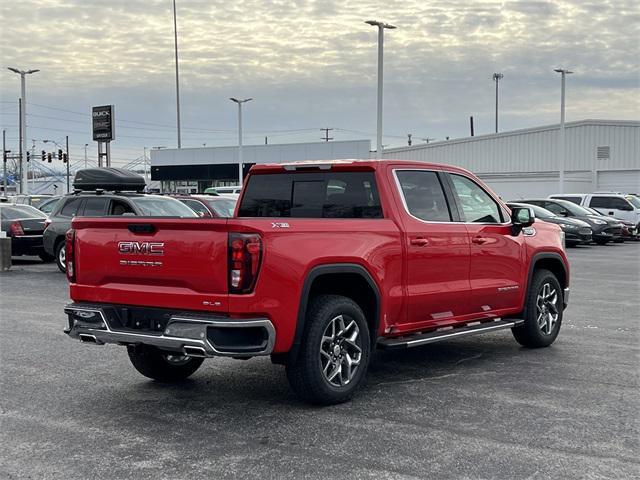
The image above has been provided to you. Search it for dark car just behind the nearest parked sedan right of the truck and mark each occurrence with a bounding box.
[520,198,622,245]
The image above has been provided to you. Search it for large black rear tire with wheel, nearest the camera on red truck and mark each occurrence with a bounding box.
[286,295,371,405]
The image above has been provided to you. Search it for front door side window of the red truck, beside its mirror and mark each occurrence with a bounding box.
[450,174,504,223]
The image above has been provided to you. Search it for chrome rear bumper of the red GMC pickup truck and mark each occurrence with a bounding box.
[64,303,276,357]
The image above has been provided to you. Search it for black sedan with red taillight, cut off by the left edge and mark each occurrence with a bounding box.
[0,203,53,262]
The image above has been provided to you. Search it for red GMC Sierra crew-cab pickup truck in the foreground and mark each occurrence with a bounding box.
[65,160,569,404]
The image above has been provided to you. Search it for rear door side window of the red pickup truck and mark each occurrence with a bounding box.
[396,170,451,222]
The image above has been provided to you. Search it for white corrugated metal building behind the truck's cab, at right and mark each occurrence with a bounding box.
[383,120,640,199]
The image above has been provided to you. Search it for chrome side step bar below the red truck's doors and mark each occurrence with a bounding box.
[378,318,524,350]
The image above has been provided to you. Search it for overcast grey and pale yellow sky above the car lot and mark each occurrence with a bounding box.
[0,0,640,166]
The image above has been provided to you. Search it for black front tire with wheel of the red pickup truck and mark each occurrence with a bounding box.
[511,269,563,348]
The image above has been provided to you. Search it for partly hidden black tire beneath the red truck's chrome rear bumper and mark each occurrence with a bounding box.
[127,345,204,383]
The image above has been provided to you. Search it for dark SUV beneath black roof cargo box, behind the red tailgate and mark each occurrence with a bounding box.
[44,191,196,272]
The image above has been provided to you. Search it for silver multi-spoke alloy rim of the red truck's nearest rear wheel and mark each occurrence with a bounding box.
[320,315,362,387]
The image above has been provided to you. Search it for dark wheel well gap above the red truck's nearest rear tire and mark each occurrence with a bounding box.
[305,273,379,343]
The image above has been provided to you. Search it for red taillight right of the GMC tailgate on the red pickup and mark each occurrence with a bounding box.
[229,233,262,293]
